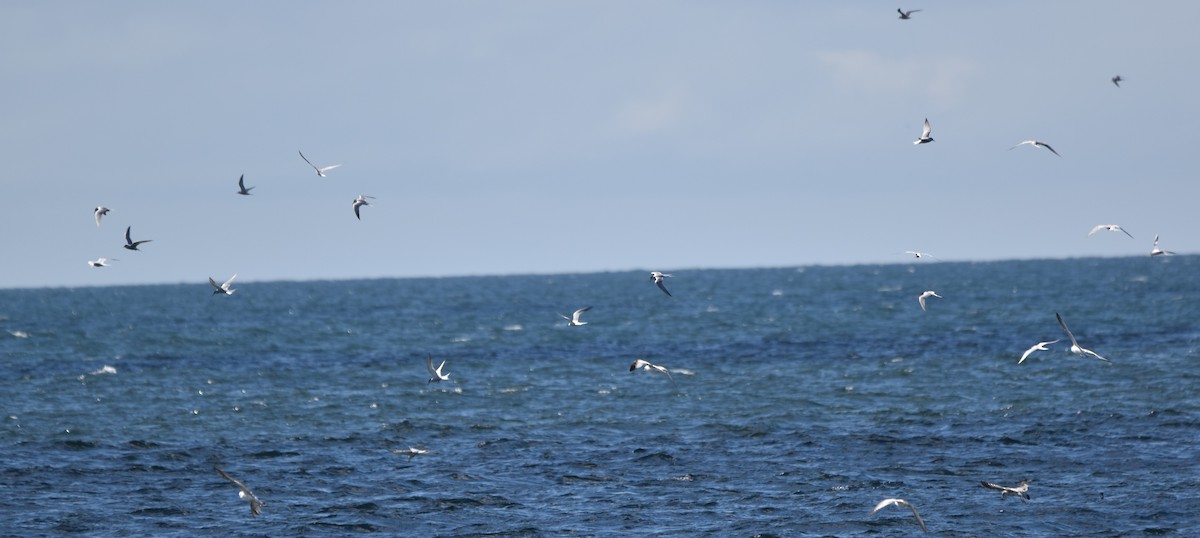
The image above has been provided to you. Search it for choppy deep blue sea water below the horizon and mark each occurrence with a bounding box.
[0,256,1200,537]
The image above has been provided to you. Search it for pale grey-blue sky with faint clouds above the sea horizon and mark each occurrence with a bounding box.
[0,0,1200,287]
